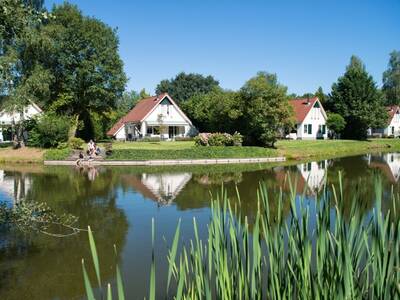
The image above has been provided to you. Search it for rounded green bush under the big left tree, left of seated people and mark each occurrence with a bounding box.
[28,113,71,148]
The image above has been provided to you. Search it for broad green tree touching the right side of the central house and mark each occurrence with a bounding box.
[182,87,243,133]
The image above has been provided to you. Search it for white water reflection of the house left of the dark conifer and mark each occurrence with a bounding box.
[297,160,329,192]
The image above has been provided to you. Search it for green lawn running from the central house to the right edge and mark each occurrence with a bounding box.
[104,139,400,160]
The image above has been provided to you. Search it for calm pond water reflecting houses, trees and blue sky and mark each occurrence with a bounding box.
[0,153,400,300]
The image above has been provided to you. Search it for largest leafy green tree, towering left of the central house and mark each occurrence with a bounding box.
[26,3,127,139]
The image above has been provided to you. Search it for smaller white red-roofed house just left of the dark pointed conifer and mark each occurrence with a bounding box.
[289,97,328,140]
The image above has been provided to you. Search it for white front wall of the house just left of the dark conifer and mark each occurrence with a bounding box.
[297,107,328,140]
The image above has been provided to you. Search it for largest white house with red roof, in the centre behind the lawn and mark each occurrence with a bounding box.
[107,93,196,141]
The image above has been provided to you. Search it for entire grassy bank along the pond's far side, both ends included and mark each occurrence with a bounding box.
[0,139,400,163]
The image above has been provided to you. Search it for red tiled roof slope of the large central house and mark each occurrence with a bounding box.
[107,93,167,136]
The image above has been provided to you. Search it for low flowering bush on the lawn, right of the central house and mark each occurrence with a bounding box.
[194,132,243,146]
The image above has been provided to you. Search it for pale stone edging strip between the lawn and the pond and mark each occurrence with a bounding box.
[44,156,286,166]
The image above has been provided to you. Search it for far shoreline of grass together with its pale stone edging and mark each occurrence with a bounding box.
[0,139,400,166]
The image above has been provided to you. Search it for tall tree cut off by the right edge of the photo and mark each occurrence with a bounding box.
[382,51,400,105]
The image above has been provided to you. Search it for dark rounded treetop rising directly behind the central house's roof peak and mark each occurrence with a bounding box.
[156,72,219,103]
